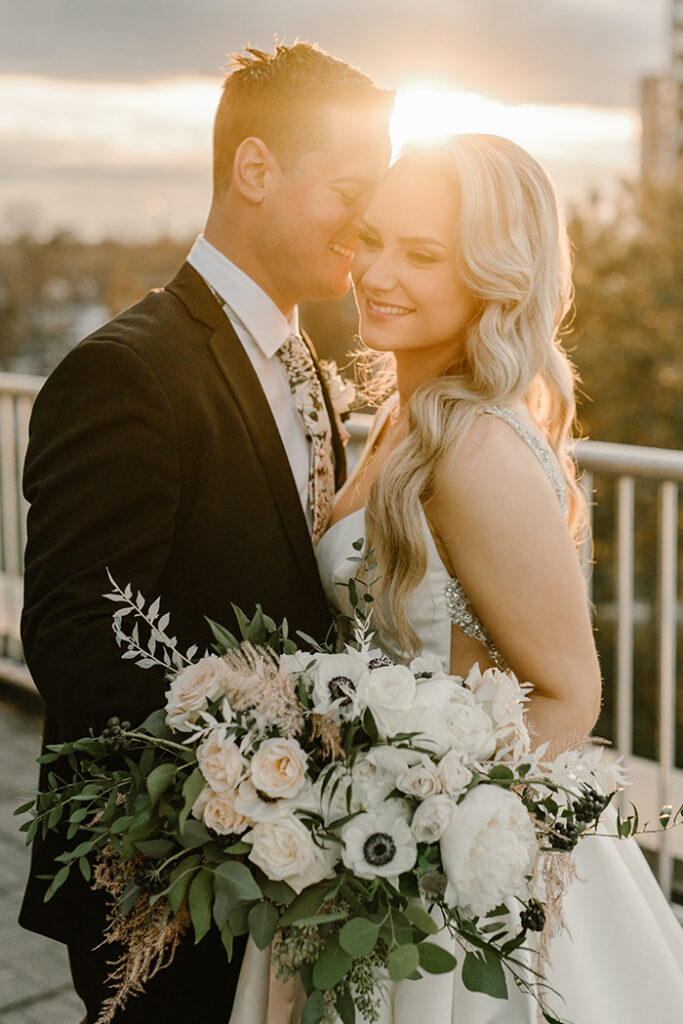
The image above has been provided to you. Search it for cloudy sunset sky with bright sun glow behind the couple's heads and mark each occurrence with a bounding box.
[0,0,670,240]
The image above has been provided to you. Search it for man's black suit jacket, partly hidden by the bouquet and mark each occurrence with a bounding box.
[19,263,345,942]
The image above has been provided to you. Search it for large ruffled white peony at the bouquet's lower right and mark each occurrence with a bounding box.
[440,785,538,916]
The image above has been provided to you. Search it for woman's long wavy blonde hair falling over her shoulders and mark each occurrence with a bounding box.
[367,135,585,652]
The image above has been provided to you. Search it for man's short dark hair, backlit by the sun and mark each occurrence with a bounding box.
[213,43,393,191]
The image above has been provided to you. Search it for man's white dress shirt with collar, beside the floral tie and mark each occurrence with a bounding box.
[187,234,312,529]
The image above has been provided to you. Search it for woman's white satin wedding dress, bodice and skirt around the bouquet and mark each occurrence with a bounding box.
[230,407,683,1024]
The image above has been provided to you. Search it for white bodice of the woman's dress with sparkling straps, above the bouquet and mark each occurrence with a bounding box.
[317,406,567,668]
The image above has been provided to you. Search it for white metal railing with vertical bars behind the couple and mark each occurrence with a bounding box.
[0,385,683,897]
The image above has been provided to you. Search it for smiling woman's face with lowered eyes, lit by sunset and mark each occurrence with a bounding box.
[351,160,475,372]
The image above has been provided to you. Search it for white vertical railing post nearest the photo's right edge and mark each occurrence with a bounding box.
[657,480,678,899]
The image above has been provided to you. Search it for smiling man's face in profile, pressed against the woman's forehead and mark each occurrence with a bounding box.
[264,105,390,311]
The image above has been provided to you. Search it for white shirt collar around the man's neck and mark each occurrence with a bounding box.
[187,234,299,359]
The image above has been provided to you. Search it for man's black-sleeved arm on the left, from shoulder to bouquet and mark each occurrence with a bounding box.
[22,340,179,735]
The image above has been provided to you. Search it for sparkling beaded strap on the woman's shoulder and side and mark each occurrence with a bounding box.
[445,406,568,669]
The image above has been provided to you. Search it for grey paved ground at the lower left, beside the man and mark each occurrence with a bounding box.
[0,683,85,1024]
